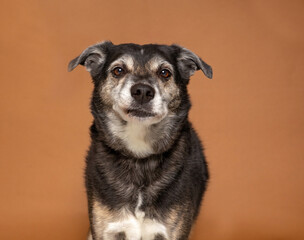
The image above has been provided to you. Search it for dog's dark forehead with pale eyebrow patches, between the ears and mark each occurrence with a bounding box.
[110,44,173,70]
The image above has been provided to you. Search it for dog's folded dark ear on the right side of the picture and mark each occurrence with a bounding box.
[173,45,212,80]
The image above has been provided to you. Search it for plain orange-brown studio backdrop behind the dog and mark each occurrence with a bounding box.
[0,0,304,240]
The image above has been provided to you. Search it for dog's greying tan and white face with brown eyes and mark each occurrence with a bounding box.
[99,49,180,125]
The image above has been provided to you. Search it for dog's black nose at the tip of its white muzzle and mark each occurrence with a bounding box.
[131,83,155,104]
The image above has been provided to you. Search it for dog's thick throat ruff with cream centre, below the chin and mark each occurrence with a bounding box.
[93,108,188,158]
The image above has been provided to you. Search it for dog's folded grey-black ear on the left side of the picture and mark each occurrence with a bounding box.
[68,41,113,75]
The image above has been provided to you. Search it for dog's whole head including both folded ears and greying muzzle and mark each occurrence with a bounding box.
[68,41,212,156]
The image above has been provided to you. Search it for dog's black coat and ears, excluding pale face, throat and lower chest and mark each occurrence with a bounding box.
[69,42,212,240]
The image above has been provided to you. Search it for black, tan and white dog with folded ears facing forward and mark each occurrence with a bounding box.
[68,41,212,240]
